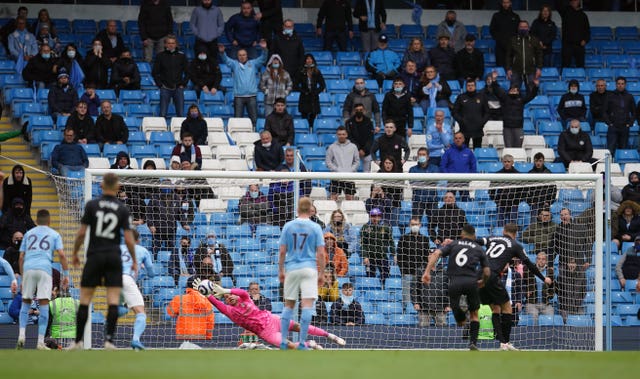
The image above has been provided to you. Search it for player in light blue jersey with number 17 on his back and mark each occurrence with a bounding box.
[278,197,325,350]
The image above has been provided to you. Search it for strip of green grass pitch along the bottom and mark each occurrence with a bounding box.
[0,350,639,379]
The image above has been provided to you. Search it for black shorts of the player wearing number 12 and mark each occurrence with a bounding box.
[80,251,122,287]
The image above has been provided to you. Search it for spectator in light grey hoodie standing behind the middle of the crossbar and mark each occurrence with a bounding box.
[325,126,360,200]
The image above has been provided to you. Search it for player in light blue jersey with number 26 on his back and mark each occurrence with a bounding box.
[16,209,69,350]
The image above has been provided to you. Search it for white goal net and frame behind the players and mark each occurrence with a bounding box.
[59,170,610,350]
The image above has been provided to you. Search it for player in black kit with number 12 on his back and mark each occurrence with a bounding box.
[69,173,138,350]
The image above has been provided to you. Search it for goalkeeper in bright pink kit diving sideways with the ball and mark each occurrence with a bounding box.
[193,279,346,350]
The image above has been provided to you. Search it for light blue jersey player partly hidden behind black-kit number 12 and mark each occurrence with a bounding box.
[120,229,155,350]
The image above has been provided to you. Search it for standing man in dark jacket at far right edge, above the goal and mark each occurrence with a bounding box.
[604,76,636,156]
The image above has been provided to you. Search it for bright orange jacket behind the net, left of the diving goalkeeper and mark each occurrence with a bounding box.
[167,288,215,340]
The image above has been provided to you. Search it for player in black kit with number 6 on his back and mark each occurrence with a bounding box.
[422,224,490,350]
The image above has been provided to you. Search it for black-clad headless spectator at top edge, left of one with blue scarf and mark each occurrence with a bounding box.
[316,0,353,51]
